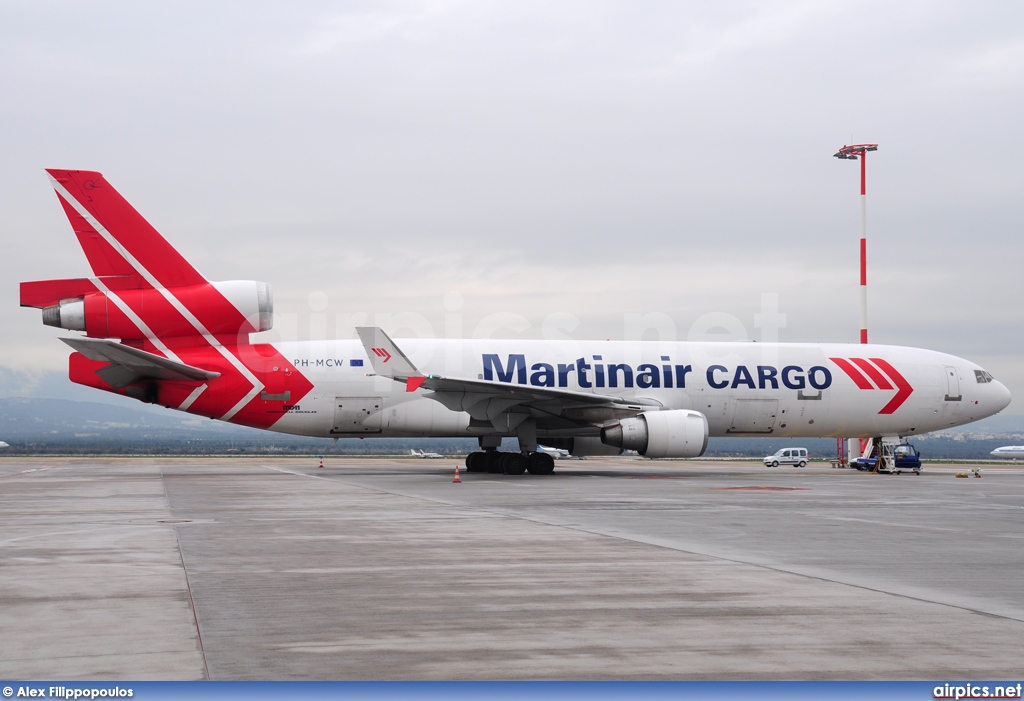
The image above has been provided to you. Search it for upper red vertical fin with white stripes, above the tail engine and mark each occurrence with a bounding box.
[46,168,207,288]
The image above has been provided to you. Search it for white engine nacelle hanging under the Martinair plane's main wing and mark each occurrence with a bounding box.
[601,409,708,457]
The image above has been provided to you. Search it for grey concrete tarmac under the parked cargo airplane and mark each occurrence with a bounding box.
[0,457,1024,681]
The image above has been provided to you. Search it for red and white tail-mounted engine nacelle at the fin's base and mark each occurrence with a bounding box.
[43,280,273,339]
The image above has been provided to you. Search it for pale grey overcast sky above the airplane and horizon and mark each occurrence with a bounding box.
[0,0,1024,418]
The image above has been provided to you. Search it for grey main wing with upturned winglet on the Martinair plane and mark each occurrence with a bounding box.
[355,326,662,428]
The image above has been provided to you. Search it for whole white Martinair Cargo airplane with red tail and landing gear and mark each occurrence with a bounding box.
[20,170,1010,474]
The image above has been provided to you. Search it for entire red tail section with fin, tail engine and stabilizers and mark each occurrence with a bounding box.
[22,170,313,428]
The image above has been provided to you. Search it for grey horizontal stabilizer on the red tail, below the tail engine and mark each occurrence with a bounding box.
[60,339,220,389]
